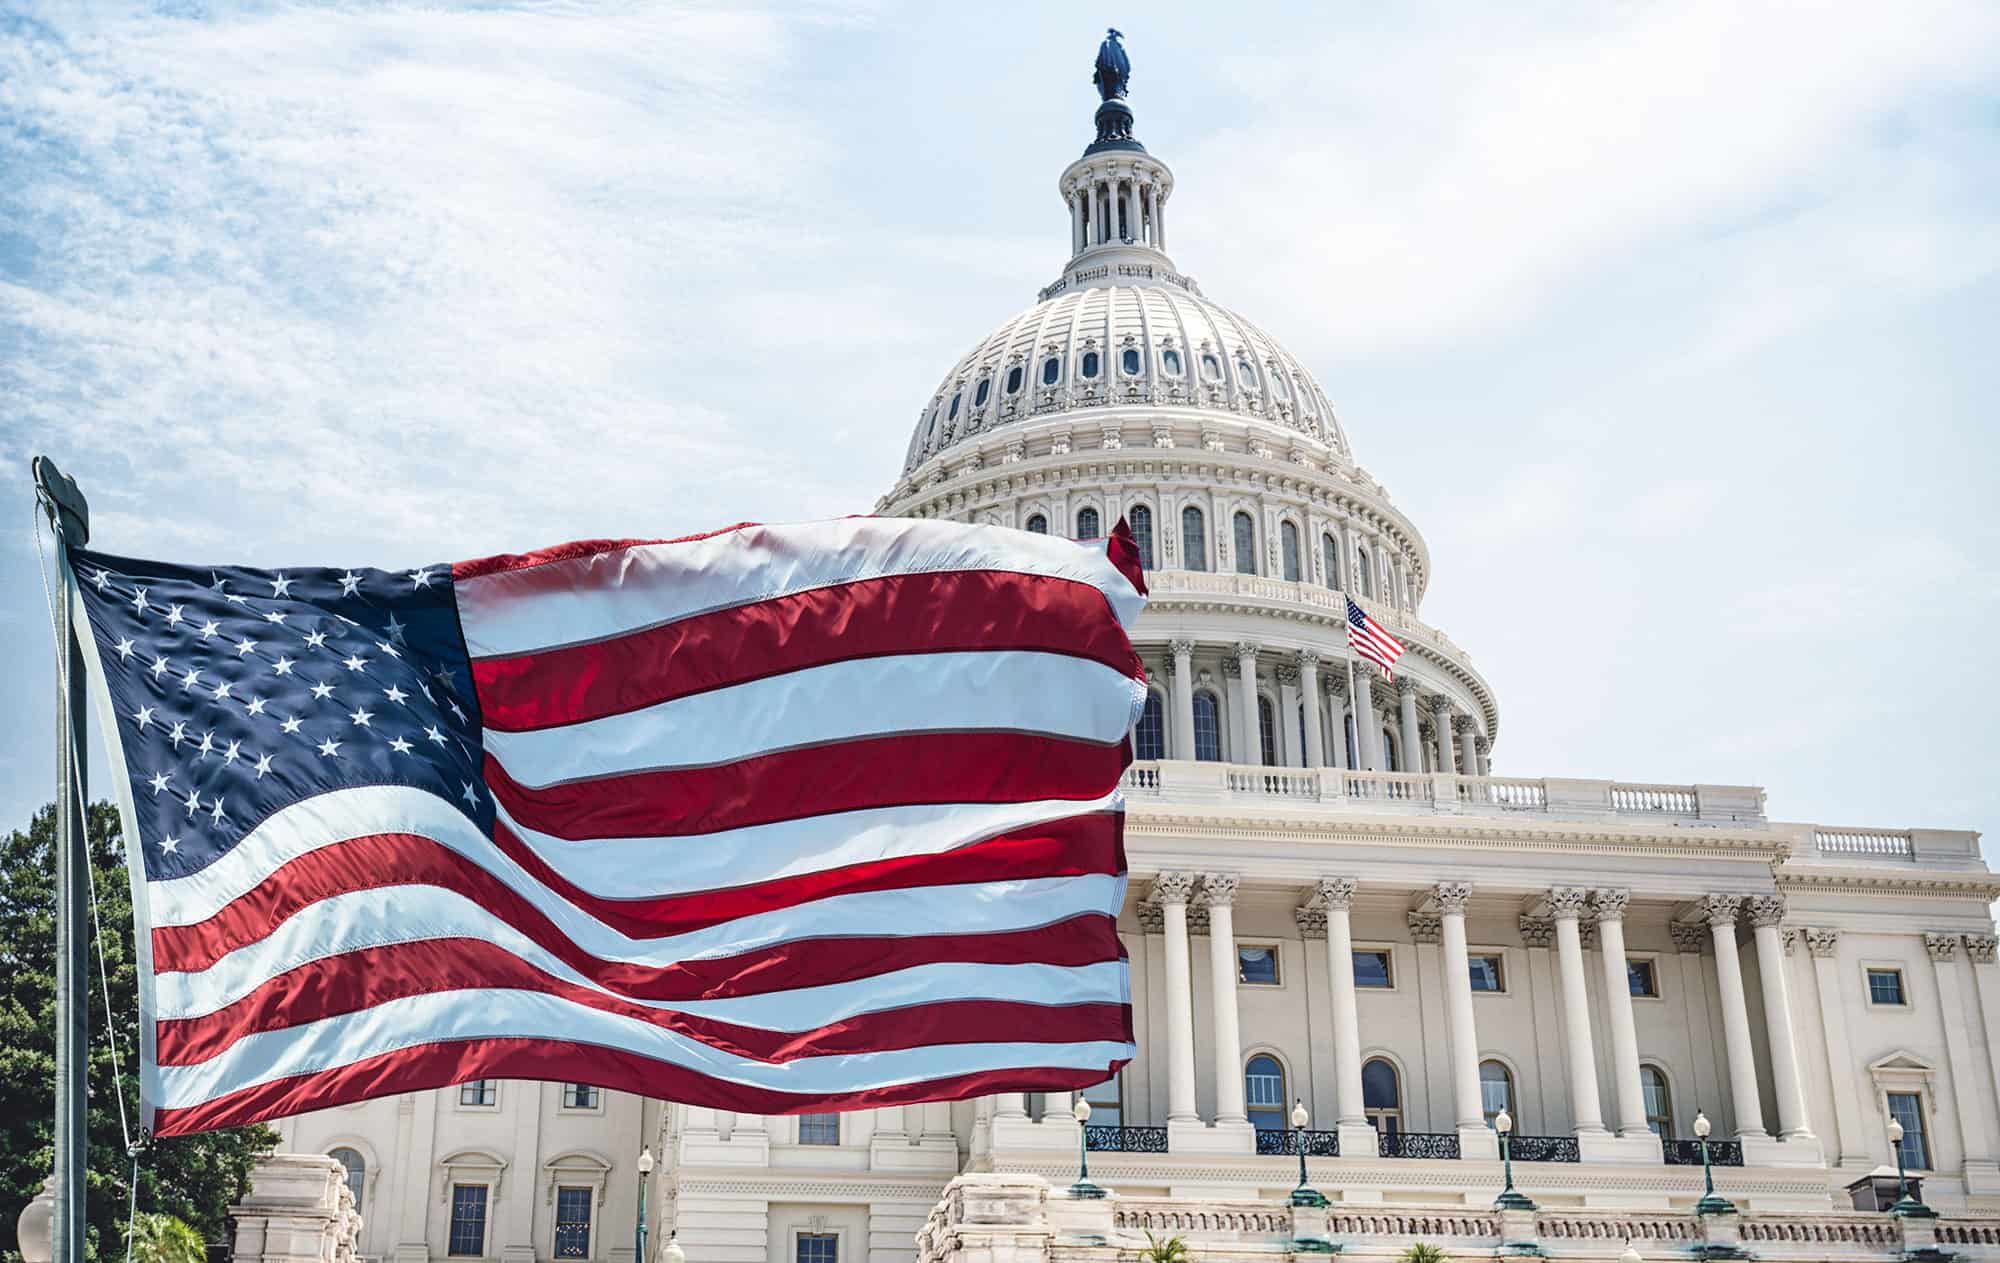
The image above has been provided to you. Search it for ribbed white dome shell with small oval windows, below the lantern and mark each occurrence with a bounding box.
[904,277,1352,472]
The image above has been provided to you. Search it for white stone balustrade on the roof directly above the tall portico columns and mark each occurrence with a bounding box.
[1124,759,1764,823]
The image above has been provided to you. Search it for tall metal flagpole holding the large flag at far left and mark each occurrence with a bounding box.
[34,456,90,1263]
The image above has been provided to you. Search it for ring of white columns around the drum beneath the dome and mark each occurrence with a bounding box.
[1162,639,1492,775]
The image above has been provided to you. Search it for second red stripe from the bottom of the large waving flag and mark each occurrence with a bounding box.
[158,939,1132,1065]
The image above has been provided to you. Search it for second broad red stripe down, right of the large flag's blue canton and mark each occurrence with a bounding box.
[486,731,1132,837]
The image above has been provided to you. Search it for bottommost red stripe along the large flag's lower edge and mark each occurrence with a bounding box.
[154,1039,1124,1135]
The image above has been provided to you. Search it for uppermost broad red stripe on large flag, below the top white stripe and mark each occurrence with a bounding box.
[472,571,1146,731]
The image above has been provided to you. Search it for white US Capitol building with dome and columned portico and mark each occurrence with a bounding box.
[258,38,2000,1263]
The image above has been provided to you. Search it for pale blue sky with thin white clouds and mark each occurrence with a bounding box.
[0,0,2000,863]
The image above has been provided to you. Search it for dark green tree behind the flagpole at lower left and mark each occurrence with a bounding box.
[0,803,278,1263]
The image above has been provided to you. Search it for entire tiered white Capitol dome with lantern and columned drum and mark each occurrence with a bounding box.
[878,40,1500,771]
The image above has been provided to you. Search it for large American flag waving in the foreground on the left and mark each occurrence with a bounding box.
[70,518,1144,1135]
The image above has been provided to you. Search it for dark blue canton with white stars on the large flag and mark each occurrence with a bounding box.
[70,550,492,881]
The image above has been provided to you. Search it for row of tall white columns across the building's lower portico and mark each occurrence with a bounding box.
[1120,871,1816,1161]
